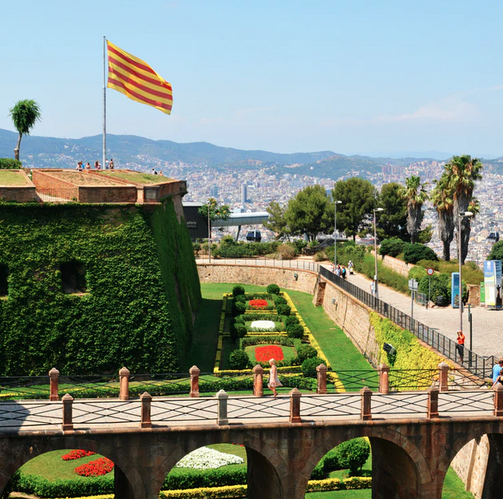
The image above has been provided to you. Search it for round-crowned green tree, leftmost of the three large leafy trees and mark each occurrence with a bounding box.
[285,185,334,241]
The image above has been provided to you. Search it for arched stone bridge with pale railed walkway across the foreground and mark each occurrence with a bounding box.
[0,380,503,499]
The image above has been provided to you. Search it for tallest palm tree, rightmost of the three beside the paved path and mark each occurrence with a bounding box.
[445,154,484,264]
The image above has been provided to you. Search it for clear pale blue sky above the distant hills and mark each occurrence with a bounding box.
[0,0,503,158]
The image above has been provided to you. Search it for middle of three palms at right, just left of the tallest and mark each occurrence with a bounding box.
[430,176,455,262]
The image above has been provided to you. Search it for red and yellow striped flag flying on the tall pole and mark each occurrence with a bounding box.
[107,40,173,114]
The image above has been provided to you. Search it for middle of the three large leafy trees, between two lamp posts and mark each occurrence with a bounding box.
[332,177,377,241]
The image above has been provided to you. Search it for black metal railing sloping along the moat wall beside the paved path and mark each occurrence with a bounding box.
[320,267,496,379]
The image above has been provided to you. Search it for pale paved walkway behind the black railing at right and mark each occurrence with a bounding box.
[330,265,503,357]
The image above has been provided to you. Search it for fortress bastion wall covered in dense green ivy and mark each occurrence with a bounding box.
[0,199,201,375]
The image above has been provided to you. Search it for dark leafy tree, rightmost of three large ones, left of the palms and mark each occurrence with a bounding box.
[376,182,408,240]
